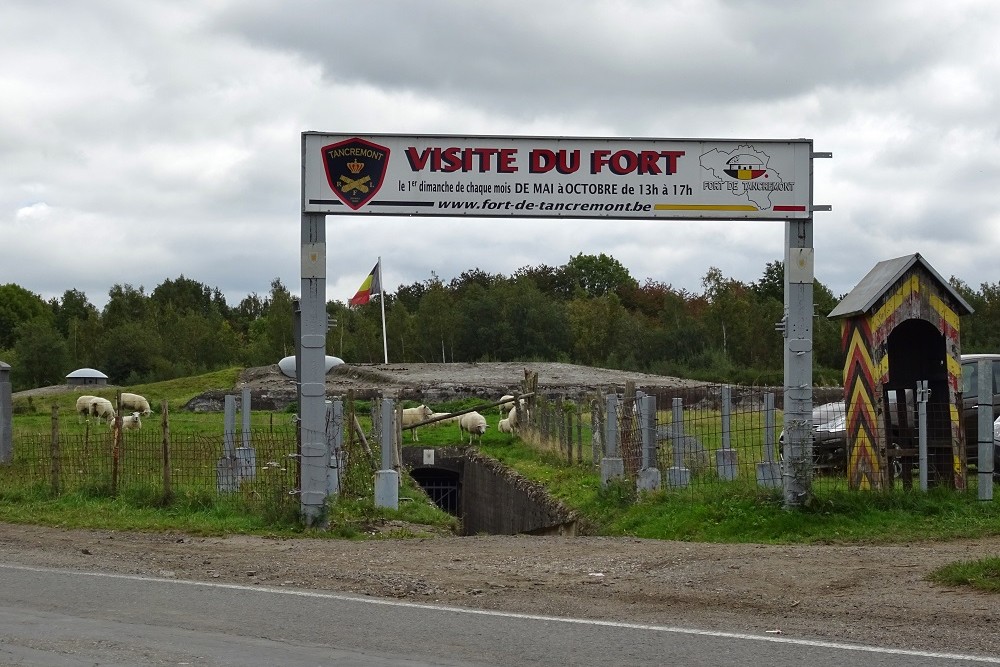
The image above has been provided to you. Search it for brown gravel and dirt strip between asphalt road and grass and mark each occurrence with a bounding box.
[0,524,1000,656]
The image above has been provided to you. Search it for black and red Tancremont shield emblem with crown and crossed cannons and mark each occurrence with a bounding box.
[322,138,389,211]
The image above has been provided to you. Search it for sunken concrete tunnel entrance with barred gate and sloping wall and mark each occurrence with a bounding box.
[402,447,577,535]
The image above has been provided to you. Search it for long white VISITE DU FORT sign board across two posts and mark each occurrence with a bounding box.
[302,132,812,220]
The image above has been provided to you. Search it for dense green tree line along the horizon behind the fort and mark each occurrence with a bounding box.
[0,253,1000,391]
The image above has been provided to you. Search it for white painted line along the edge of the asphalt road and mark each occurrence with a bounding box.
[0,563,1000,664]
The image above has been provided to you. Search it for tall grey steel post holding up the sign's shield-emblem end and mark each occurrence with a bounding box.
[296,213,330,526]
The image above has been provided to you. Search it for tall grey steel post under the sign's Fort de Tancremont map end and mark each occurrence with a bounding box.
[782,218,813,509]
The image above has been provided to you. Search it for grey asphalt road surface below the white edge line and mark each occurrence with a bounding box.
[0,565,1000,667]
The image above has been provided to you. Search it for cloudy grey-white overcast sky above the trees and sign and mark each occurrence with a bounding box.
[0,0,1000,307]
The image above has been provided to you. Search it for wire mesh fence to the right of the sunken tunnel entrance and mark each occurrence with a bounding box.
[521,384,975,493]
